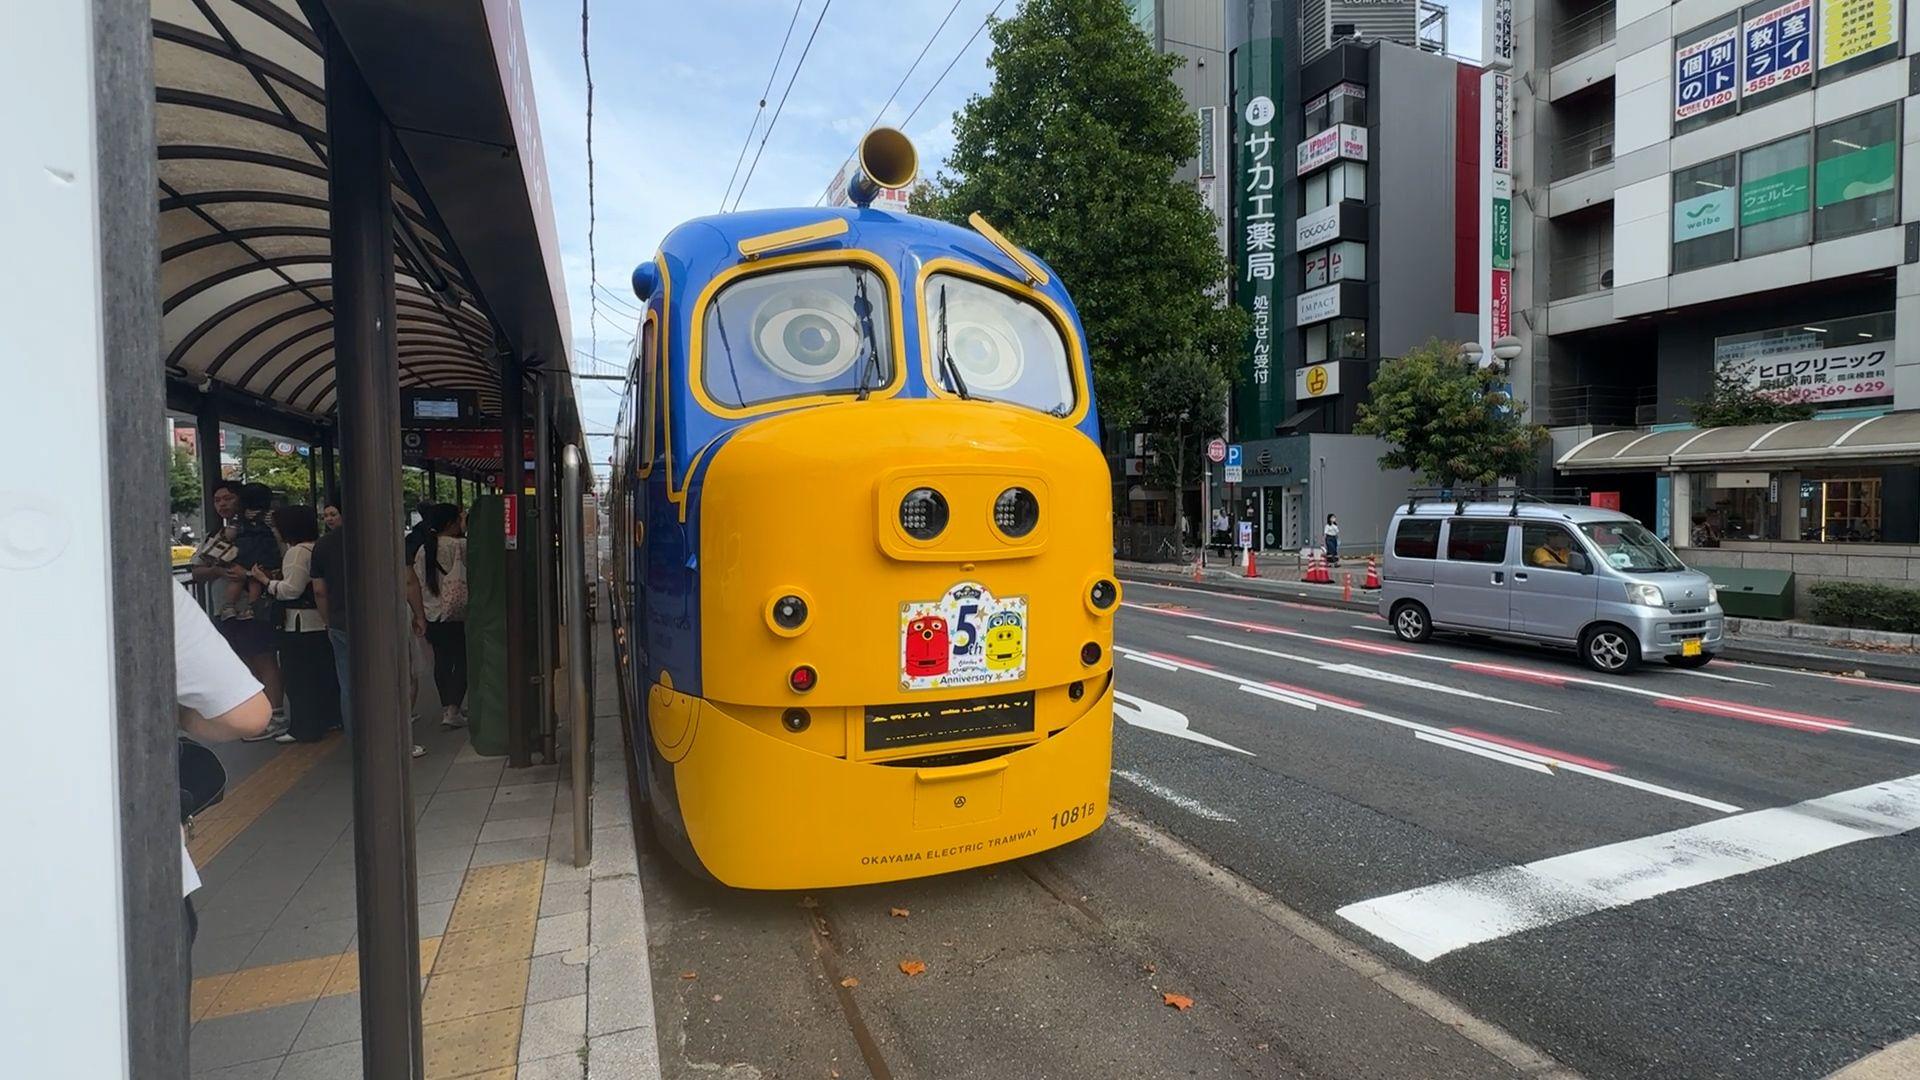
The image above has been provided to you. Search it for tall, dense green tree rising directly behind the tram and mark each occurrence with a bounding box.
[914,0,1246,430]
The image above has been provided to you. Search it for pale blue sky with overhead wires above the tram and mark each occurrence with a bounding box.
[520,0,1480,461]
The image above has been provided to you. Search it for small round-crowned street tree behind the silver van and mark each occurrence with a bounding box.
[1354,340,1548,486]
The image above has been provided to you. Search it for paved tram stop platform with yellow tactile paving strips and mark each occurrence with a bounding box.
[188,634,659,1080]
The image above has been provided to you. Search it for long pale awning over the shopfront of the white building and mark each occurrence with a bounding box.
[1553,411,1920,473]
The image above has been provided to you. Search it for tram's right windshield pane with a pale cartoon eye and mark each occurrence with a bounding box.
[922,273,1073,417]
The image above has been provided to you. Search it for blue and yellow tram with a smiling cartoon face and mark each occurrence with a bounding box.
[611,129,1119,888]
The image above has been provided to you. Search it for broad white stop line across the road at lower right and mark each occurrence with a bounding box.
[1336,776,1920,961]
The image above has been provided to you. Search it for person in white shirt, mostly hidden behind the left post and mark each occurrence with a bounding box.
[173,586,273,978]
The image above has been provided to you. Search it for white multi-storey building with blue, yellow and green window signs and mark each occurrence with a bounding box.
[1501,0,1920,592]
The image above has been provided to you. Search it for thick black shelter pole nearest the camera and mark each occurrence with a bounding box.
[326,33,422,1080]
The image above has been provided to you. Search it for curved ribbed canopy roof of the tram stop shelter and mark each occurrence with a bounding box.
[152,0,570,428]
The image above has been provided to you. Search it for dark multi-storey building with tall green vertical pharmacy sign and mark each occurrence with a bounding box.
[1221,0,1480,550]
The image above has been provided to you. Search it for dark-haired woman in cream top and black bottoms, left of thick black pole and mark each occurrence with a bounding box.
[252,505,340,742]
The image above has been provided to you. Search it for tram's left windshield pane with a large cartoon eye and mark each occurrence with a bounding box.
[701,265,893,409]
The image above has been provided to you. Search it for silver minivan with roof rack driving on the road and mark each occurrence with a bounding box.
[1380,500,1722,673]
